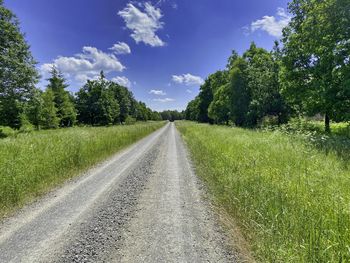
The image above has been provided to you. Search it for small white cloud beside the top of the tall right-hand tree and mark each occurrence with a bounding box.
[250,8,291,37]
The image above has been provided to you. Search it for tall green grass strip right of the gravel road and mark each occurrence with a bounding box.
[176,122,350,263]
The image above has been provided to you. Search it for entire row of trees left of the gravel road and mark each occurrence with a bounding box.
[0,0,173,129]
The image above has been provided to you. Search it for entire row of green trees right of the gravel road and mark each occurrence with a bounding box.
[185,0,350,132]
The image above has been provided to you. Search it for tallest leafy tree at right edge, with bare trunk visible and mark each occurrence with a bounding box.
[281,0,350,132]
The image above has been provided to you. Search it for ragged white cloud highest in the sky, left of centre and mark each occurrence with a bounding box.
[118,3,165,47]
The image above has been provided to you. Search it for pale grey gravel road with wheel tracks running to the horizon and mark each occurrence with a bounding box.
[0,123,237,263]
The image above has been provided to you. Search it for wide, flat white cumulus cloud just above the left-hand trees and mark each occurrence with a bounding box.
[40,46,125,82]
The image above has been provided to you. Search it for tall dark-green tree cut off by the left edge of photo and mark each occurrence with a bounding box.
[0,1,39,128]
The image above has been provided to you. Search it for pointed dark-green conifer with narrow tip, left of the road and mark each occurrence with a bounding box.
[47,67,77,127]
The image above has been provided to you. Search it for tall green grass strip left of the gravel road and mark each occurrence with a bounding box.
[0,122,164,217]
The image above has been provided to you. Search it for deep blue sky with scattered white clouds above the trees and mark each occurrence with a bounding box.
[5,0,290,110]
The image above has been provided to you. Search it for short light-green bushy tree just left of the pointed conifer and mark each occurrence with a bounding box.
[39,88,60,129]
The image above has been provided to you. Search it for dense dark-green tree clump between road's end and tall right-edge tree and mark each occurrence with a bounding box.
[185,43,289,127]
